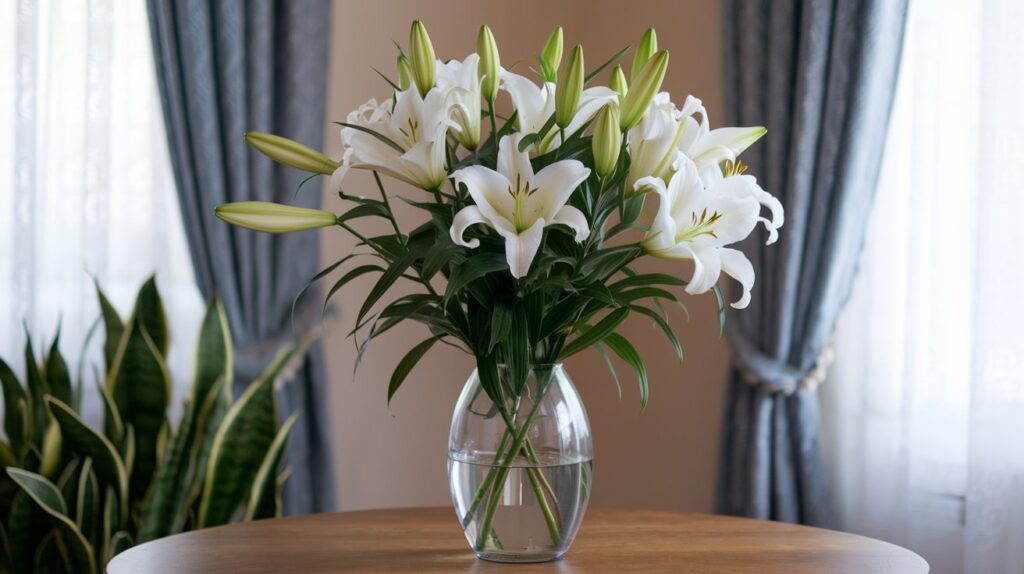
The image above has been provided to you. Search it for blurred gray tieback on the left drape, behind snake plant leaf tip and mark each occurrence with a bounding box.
[234,297,330,387]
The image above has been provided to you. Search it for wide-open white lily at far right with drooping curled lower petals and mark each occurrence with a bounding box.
[636,158,761,309]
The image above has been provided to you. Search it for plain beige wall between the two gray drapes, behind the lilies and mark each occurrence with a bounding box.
[323,0,727,512]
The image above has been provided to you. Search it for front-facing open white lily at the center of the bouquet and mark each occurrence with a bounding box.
[452,134,590,278]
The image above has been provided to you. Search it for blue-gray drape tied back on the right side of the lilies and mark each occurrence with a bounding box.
[718,0,906,526]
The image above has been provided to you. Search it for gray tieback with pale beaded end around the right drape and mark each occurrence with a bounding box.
[729,335,836,395]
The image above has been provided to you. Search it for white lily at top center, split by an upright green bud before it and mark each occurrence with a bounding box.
[502,69,618,157]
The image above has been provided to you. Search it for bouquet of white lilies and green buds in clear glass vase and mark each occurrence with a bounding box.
[217,21,782,562]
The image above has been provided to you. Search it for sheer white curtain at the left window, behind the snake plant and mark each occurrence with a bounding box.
[0,0,203,421]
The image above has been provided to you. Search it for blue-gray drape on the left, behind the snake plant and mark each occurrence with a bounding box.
[148,0,334,514]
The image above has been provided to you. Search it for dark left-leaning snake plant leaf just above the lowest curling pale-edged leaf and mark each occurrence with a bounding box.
[49,397,128,523]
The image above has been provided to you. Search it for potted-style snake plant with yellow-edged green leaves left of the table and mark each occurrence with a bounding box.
[0,278,302,574]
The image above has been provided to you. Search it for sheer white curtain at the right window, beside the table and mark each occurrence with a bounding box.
[822,0,1024,574]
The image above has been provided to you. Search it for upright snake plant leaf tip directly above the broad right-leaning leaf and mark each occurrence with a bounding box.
[191,297,234,408]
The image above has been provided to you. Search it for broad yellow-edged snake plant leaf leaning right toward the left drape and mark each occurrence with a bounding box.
[199,361,280,528]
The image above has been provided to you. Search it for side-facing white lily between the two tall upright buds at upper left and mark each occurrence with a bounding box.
[436,54,482,149]
